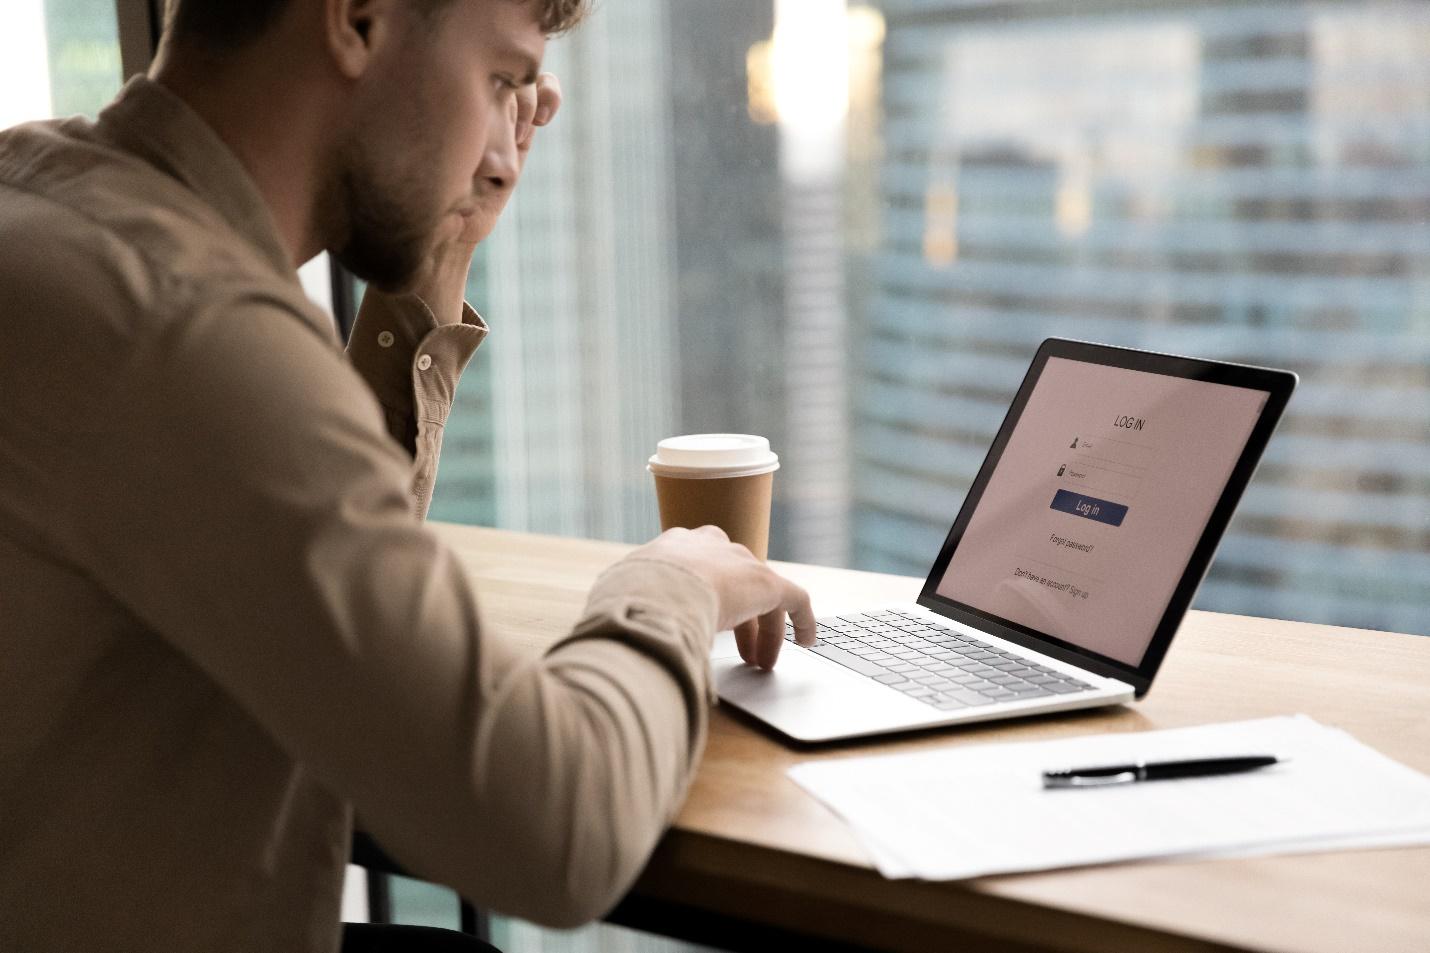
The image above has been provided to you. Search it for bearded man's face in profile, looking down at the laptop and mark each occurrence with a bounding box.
[325,0,546,290]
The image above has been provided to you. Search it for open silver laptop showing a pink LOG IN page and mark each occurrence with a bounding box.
[711,338,1297,741]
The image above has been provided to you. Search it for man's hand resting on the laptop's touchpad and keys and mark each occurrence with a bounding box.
[632,527,815,668]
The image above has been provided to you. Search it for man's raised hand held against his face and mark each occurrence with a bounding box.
[412,73,561,323]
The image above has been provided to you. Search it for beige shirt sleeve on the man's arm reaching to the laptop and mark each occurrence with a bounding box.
[51,287,718,926]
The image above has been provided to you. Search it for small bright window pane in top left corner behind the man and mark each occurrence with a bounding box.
[0,0,122,129]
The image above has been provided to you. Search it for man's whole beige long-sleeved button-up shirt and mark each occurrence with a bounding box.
[0,80,716,953]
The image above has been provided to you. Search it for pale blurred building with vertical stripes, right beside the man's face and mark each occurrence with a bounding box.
[433,1,679,539]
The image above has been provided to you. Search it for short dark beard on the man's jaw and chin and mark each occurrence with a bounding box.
[325,143,440,292]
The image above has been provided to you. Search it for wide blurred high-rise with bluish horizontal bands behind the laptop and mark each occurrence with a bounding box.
[854,0,1430,632]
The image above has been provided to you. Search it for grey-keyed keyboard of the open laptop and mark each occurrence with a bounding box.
[785,610,1093,711]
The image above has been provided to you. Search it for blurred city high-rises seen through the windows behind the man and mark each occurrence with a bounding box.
[0,0,1430,953]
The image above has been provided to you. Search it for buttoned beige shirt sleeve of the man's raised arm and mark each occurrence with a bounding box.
[347,288,488,518]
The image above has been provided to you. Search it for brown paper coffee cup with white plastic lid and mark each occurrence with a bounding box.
[646,434,779,559]
